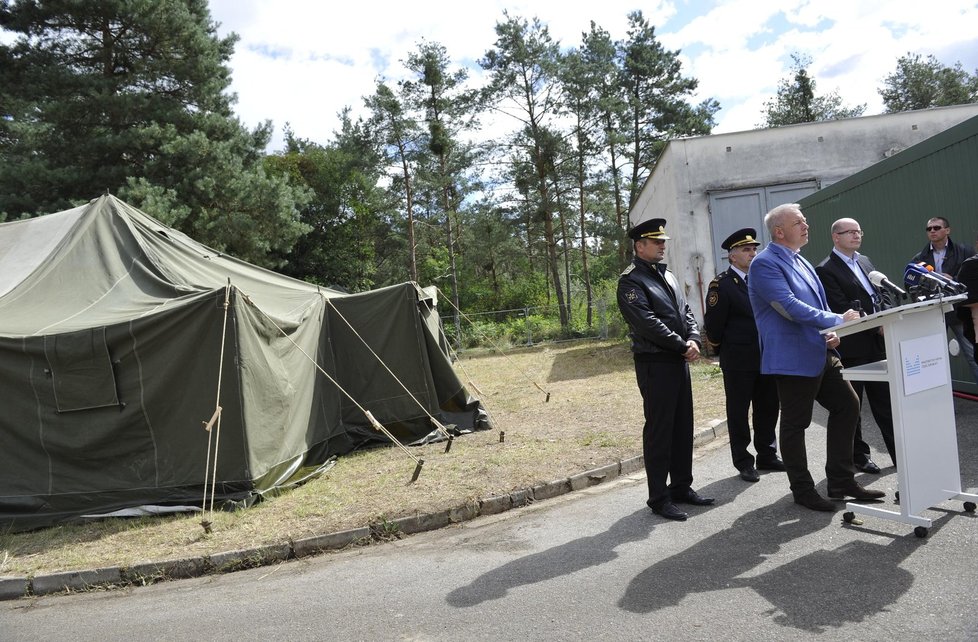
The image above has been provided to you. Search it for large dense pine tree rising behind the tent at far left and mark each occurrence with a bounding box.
[0,0,306,262]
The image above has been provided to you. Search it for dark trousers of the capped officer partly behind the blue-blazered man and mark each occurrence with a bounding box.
[723,370,779,470]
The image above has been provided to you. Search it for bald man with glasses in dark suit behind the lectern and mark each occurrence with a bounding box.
[815,218,896,474]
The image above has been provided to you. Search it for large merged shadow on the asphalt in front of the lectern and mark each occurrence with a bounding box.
[618,497,951,633]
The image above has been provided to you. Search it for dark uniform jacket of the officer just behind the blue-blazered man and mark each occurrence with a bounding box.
[703,269,761,372]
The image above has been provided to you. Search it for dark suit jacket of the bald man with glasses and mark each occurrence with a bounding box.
[815,252,892,365]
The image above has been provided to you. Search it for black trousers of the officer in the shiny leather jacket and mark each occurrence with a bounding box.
[635,357,693,507]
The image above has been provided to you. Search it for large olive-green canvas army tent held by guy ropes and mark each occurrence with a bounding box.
[0,195,488,530]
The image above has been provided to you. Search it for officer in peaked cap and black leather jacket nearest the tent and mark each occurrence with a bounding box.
[618,218,714,521]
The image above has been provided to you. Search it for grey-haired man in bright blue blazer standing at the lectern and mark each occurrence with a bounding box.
[748,203,885,511]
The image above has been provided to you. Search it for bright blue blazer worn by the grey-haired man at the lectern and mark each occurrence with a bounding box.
[747,243,842,377]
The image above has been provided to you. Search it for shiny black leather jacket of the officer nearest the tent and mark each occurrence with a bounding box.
[618,257,700,359]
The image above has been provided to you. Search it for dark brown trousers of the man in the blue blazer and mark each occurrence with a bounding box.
[776,352,859,497]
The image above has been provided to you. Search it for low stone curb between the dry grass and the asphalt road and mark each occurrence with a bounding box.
[0,420,727,600]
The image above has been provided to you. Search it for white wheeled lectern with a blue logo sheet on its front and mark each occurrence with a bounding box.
[823,294,978,537]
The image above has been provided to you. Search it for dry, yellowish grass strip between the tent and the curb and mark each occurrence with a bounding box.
[0,341,724,575]
